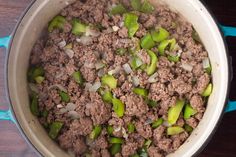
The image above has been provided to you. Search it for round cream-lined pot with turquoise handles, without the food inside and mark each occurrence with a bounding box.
[0,0,236,157]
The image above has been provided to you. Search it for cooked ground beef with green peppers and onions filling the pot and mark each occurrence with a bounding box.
[28,0,212,157]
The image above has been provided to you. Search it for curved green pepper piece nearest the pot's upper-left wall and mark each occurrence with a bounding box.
[48,16,66,32]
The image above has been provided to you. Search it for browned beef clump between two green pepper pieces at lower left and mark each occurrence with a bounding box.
[70,118,93,136]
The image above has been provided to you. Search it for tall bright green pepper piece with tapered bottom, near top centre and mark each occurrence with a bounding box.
[124,13,139,38]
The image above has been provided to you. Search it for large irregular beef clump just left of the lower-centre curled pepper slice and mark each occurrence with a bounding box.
[85,93,111,125]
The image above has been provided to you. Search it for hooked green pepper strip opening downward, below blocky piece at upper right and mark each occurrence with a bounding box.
[158,39,176,56]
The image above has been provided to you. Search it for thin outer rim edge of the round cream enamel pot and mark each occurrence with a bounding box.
[4,0,232,156]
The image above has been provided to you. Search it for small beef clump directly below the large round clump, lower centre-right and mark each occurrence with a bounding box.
[135,121,152,139]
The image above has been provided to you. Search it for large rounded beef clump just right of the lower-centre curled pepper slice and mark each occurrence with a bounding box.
[124,94,148,117]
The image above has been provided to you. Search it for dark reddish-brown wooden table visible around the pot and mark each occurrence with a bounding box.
[0,0,236,157]
